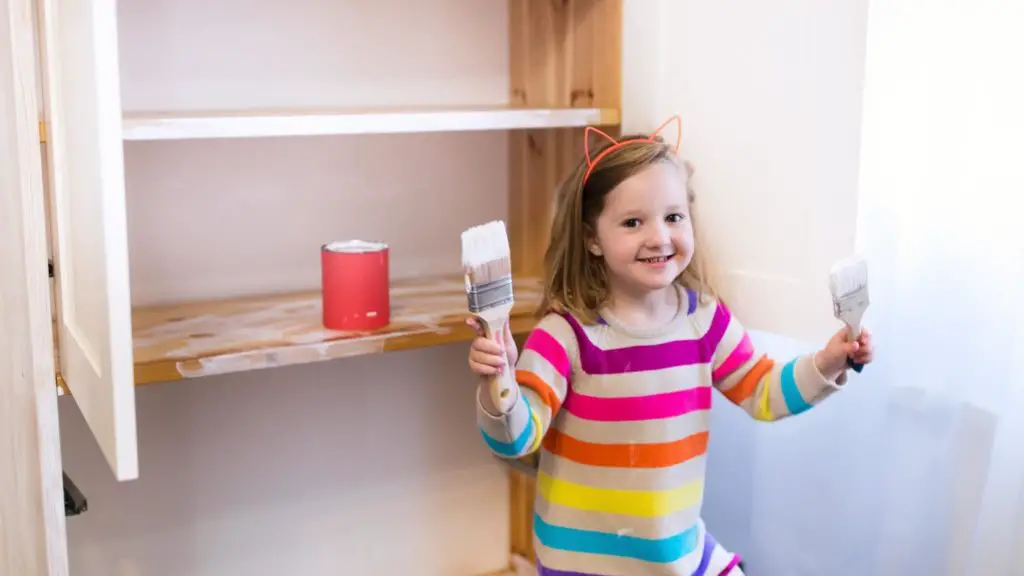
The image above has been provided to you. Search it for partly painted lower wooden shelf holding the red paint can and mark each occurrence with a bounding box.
[132,277,541,384]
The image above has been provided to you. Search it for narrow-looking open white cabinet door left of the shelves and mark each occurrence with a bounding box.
[41,0,138,481]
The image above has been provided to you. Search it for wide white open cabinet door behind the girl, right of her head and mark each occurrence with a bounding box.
[623,0,867,341]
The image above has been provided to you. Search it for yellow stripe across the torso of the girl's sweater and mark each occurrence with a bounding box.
[537,471,703,518]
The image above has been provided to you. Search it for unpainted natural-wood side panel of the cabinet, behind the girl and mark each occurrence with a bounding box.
[508,0,623,560]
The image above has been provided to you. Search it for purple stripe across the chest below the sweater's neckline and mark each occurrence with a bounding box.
[563,303,731,374]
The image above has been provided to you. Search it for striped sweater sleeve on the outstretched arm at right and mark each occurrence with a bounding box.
[703,302,840,421]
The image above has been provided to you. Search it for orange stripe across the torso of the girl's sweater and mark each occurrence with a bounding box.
[544,428,708,468]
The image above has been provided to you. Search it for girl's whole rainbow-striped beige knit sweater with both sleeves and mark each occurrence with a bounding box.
[477,292,839,576]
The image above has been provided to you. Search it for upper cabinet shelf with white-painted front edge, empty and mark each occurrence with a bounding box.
[122,107,620,140]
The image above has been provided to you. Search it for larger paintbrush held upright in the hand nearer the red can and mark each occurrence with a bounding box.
[462,220,517,414]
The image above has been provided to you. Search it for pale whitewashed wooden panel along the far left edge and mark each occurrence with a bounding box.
[0,0,68,576]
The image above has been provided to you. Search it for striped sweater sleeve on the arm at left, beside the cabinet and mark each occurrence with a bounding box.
[476,315,575,458]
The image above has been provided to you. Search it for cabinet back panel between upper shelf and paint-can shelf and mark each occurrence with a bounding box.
[125,132,508,305]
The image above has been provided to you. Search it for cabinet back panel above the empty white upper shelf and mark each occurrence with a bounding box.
[118,0,509,111]
